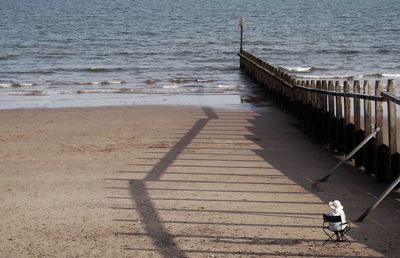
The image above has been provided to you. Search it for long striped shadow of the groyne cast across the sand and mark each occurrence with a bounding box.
[107,106,399,257]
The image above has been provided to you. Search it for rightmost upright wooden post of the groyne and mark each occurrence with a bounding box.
[385,80,398,181]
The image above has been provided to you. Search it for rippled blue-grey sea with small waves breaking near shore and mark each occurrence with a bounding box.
[0,0,400,108]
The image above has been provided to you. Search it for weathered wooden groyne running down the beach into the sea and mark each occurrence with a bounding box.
[239,48,400,182]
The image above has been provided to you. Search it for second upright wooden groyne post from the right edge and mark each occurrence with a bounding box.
[374,81,385,182]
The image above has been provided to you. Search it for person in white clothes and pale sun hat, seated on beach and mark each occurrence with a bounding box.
[325,200,350,241]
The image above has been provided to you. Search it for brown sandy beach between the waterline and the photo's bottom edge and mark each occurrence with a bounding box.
[0,106,400,257]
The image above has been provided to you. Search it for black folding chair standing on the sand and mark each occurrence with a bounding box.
[322,214,351,246]
